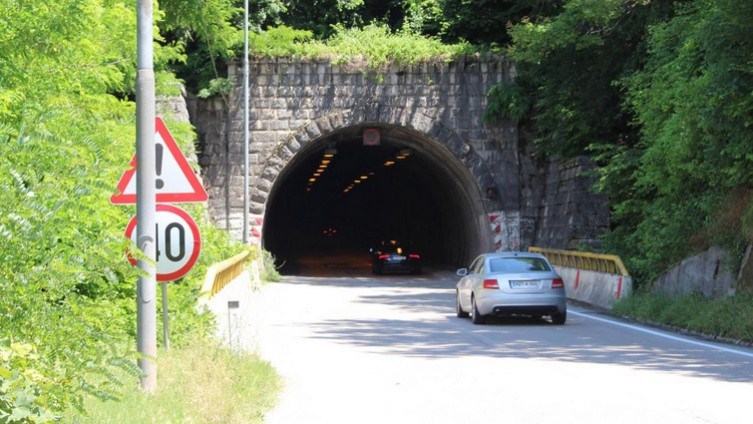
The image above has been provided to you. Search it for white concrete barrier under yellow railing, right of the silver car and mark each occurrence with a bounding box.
[554,265,633,309]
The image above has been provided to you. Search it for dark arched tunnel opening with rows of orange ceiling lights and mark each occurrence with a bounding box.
[262,126,490,273]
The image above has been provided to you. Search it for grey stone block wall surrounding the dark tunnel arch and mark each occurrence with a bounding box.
[189,56,608,250]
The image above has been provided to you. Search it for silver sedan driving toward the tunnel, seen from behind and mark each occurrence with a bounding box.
[455,252,567,324]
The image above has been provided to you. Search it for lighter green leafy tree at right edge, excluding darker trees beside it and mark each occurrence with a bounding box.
[605,0,753,276]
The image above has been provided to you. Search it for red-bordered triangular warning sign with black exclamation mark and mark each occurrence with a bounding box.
[110,117,207,205]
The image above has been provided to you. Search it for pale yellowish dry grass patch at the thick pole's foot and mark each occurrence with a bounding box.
[65,340,280,424]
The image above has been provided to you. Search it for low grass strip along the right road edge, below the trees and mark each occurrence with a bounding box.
[612,292,753,343]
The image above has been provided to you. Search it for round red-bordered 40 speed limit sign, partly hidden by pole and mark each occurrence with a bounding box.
[125,204,201,281]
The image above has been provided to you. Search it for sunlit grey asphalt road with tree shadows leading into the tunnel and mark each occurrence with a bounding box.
[219,253,753,424]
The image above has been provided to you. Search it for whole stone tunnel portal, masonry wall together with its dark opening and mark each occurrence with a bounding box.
[188,55,608,274]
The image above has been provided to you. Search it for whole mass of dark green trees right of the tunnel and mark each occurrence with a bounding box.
[490,0,753,283]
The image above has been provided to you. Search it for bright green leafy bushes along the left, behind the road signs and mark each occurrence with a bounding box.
[0,0,276,423]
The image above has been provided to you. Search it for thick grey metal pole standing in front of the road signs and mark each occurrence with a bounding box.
[136,0,157,392]
